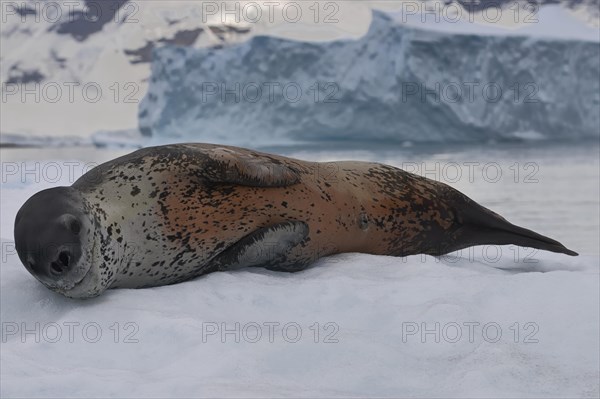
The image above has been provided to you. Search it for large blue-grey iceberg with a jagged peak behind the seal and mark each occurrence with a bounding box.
[139,11,600,146]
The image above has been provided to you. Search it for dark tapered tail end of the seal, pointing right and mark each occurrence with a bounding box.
[448,189,578,256]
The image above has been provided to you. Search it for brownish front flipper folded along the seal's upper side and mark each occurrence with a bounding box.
[202,147,300,187]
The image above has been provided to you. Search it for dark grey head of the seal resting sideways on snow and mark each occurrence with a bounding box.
[15,187,103,298]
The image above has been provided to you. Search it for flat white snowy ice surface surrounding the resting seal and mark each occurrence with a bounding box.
[0,143,600,398]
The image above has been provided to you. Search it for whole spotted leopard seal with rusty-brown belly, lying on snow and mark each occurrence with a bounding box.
[14,144,577,298]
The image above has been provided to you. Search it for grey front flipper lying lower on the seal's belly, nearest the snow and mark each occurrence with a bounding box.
[213,221,309,272]
